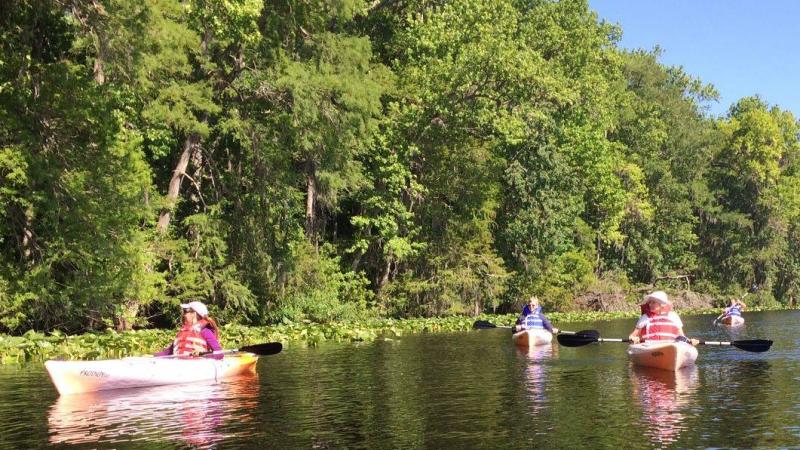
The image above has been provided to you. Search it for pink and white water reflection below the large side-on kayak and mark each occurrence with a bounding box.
[48,374,259,448]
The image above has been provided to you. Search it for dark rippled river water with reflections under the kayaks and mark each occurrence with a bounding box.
[0,311,800,449]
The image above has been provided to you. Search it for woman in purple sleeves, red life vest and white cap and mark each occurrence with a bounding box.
[156,301,223,359]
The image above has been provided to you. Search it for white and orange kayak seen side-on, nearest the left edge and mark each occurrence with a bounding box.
[44,353,258,395]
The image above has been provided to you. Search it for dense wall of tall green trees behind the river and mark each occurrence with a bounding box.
[0,0,800,333]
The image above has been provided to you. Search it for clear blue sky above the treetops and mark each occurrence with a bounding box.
[589,0,800,119]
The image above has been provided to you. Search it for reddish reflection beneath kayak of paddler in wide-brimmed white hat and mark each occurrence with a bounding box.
[630,365,699,446]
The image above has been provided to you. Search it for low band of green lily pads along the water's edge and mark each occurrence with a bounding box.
[0,296,788,365]
